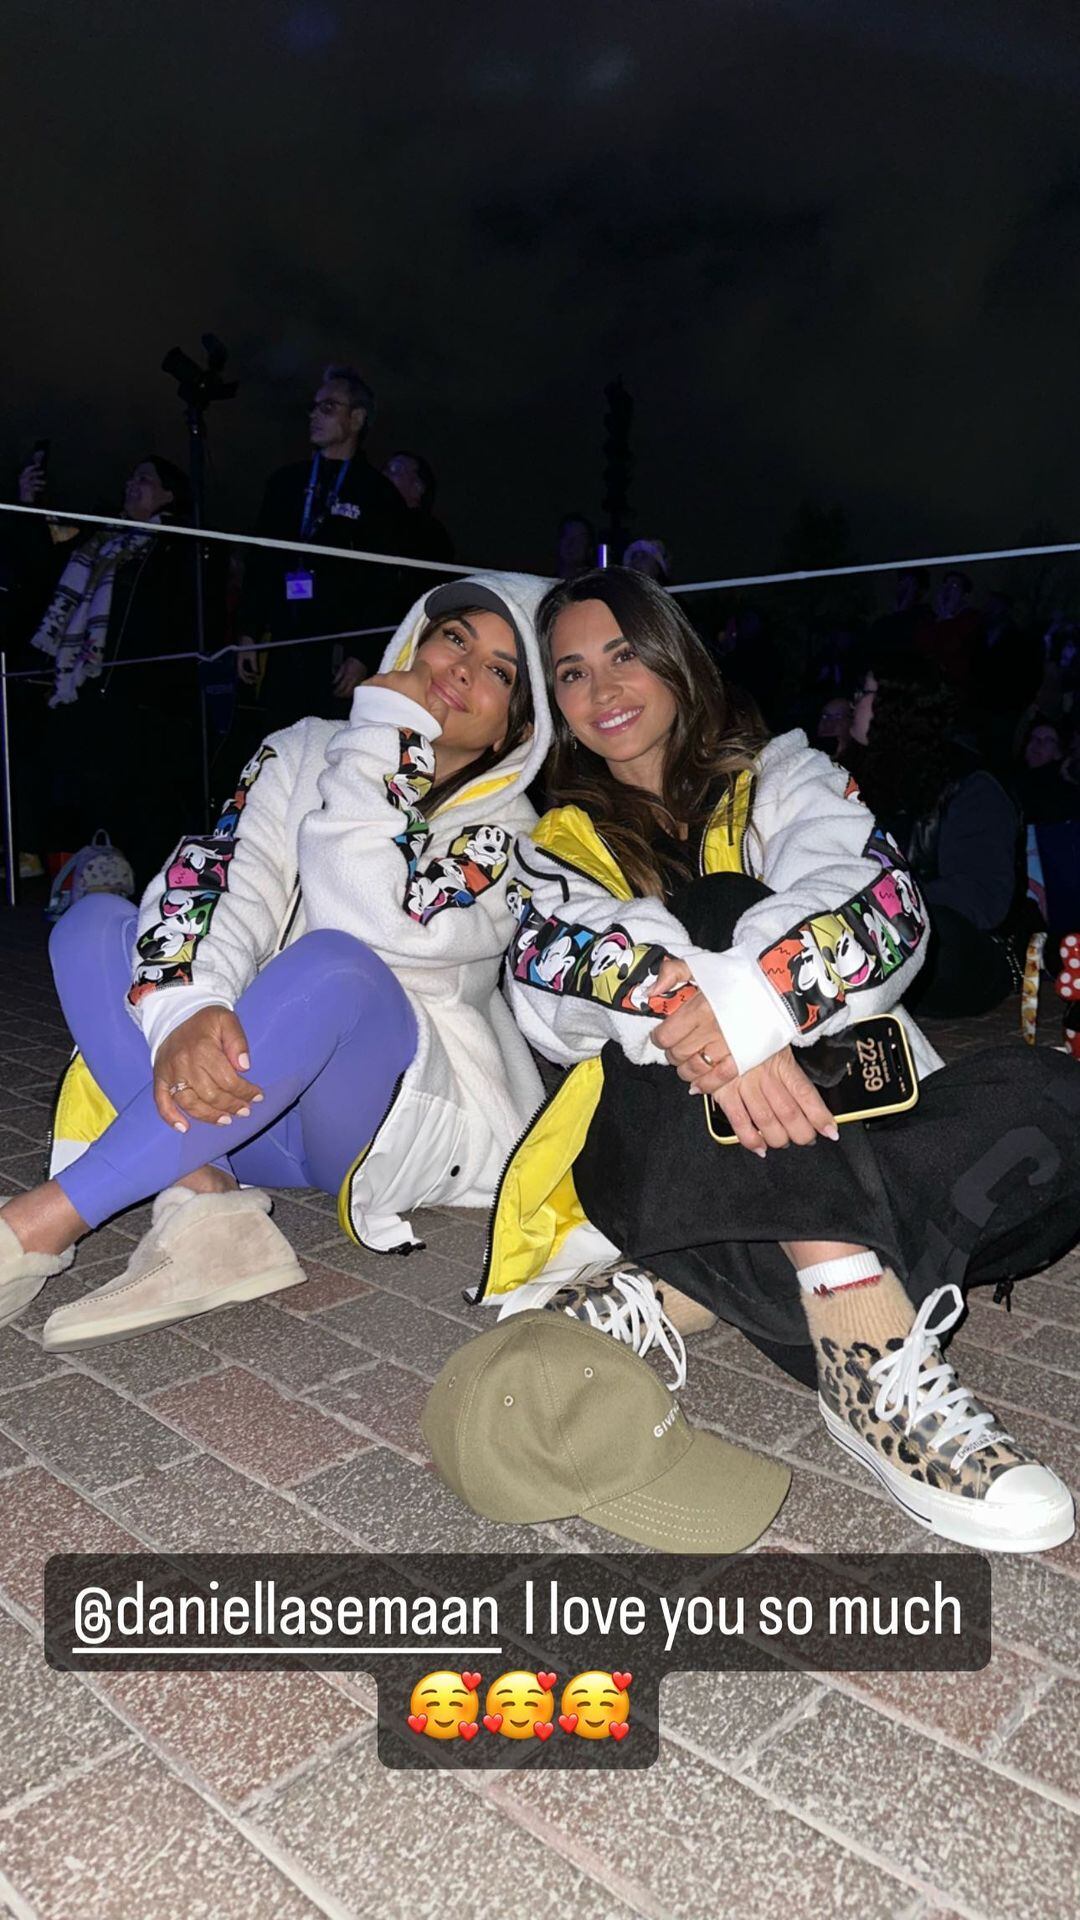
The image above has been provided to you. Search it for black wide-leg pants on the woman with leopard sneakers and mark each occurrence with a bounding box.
[575,874,1080,1382]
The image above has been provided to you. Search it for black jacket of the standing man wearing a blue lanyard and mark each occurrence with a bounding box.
[238,453,411,724]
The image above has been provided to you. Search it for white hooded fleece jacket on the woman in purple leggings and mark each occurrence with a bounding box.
[129,574,550,1250]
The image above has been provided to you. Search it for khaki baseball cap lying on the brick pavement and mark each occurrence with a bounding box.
[421,1309,792,1553]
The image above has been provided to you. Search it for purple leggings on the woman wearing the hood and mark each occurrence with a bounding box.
[48,895,417,1227]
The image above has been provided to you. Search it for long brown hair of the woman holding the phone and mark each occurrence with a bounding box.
[536,566,769,895]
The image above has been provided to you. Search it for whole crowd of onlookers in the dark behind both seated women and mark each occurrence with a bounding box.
[0,365,1080,1014]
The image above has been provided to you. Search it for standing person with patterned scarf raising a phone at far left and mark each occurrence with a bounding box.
[6,453,210,885]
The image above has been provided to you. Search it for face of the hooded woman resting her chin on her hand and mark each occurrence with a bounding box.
[417,611,519,778]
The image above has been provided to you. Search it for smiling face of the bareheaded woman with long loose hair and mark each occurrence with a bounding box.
[552,601,678,793]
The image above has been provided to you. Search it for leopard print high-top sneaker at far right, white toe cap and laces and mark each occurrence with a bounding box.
[817,1286,1074,1553]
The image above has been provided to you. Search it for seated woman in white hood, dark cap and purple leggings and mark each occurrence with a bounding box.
[0,574,550,1350]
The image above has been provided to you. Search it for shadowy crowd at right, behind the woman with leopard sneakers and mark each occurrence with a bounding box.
[764,568,1080,1018]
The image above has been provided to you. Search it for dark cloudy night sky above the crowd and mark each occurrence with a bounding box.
[0,0,1080,578]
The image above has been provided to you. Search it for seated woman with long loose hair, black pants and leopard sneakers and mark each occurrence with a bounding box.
[490,568,1080,1551]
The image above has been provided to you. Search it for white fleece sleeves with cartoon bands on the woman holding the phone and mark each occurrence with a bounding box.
[507,732,942,1077]
